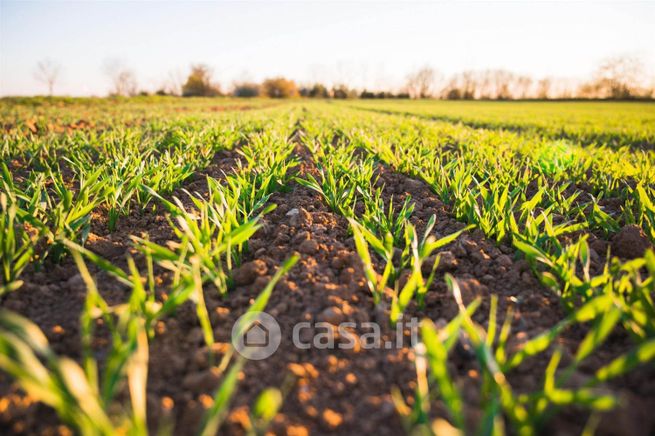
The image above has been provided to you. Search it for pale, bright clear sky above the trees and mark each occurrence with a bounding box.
[0,0,655,96]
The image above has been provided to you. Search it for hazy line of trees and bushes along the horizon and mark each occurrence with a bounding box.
[34,56,655,100]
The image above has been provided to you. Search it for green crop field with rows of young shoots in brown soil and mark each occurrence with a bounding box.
[0,97,655,435]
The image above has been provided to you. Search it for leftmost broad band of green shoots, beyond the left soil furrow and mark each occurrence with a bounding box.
[0,106,298,294]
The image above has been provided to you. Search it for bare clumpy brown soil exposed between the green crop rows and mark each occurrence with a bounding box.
[0,135,655,434]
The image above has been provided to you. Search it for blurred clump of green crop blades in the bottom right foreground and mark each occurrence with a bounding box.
[395,276,655,434]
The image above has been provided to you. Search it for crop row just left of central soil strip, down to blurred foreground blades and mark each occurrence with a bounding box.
[0,106,297,435]
